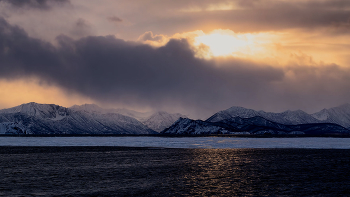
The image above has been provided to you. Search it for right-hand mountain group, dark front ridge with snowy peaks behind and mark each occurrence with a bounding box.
[161,104,350,135]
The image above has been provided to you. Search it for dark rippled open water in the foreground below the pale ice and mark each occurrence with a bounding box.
[0,147,350,196]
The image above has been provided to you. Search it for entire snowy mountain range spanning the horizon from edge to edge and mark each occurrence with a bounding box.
[0,102,350,135]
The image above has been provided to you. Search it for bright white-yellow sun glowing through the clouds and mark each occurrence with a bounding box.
[194,31,254,57]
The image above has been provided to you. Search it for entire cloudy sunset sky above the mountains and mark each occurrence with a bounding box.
[0,0,350,119]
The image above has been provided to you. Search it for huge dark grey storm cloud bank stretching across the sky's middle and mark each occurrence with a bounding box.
[0,19,350,117]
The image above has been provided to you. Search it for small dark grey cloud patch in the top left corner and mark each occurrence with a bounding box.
[0,0,70,10]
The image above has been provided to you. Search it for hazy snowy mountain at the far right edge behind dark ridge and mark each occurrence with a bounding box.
[312,104,350,128]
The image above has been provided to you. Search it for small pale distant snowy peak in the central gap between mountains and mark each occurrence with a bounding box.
[142,111,186,132]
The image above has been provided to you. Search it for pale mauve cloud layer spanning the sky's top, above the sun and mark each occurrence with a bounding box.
[0,0,350,44]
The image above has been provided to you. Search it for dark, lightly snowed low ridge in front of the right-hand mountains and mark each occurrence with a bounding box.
[161,116,350,135]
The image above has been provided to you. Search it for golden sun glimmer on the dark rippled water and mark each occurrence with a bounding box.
[184,149,255,196]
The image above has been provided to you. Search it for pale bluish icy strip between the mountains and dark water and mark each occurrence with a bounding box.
[0,137,350,149]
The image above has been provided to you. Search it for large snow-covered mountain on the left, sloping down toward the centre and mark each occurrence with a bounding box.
[0,103,156,134]
